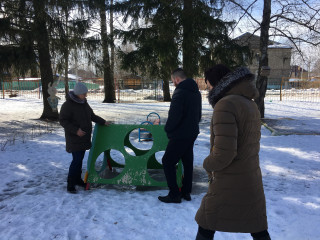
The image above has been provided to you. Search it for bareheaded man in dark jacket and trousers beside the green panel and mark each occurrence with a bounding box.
[158,68,202,203]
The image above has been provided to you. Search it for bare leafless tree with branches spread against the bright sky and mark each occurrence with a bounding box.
[227,0,320,118]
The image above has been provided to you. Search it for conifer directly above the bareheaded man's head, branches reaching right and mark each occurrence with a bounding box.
[182,0,250,77]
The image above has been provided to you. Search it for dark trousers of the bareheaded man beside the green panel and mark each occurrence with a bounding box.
[162,138,196,197]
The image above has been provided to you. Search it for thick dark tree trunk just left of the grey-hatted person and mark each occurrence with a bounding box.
[33,0,59,120]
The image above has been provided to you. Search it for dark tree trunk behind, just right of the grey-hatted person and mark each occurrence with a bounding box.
[100,1,116,103]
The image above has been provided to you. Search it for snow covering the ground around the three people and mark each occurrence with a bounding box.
[0,98,320,240]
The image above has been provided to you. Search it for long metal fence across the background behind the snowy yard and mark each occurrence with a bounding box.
[0,78,320,103]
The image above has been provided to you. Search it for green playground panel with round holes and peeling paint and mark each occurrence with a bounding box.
[87,124,183,187]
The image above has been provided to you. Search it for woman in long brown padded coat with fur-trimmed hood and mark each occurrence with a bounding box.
[195,64,270,240]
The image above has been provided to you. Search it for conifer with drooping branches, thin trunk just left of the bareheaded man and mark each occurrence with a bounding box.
[115,0,181,101]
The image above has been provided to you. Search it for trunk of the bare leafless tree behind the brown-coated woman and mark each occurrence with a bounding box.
[255,0,271,118]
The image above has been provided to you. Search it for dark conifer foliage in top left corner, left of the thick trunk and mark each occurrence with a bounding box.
[0,0,37,76]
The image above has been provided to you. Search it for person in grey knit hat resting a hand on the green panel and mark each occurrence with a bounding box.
[59,82,109,193]
